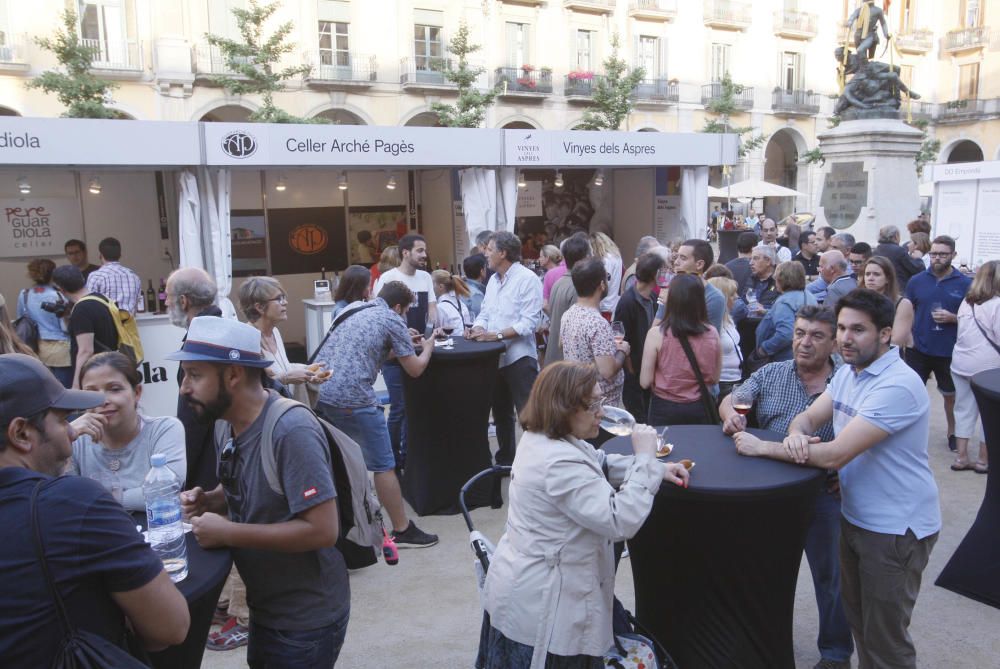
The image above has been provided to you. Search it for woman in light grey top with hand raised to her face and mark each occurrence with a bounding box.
[66,351,187,511]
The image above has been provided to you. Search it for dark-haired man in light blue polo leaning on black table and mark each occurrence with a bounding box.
[733,288,941,667]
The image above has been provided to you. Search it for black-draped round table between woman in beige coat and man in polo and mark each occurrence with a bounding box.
[604,425,825,669]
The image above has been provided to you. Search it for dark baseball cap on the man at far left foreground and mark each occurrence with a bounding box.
[0,353,104,429]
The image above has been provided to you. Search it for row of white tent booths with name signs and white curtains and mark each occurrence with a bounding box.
[0,117,737,415]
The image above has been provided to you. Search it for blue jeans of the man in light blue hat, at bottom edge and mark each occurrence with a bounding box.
[247,612,350,669]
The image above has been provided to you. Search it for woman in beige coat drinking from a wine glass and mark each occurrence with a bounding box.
[480,362,688,669]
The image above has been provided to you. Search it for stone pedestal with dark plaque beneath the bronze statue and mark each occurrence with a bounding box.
[814,119,923,247]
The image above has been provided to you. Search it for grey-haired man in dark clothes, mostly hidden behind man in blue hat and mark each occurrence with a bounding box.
[166,267,222,490]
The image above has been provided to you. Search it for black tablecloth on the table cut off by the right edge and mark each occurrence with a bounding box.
[935,369,1000,608]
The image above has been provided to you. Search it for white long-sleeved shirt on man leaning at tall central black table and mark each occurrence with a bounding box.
[473,262,542,367]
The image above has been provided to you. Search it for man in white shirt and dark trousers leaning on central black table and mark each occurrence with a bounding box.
[466,232,542,465]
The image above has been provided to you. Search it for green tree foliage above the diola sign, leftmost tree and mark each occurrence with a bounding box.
[25,9,121,118]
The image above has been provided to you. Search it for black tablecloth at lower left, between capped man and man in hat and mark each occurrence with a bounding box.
[132,513,233,669]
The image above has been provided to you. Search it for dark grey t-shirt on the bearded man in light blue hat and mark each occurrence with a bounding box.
[223,392,351,630]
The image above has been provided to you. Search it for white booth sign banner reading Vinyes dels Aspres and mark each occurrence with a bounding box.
[503,130,738,167]
